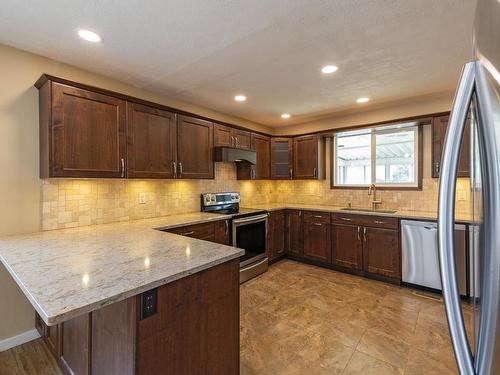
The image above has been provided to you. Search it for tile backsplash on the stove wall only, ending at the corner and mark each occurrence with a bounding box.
[42,163,274,230]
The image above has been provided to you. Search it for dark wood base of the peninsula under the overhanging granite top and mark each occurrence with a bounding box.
[36,259,240,375]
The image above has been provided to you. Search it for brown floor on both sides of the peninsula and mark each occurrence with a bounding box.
[0,260,471,375]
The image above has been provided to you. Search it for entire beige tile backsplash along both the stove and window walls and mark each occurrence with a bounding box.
[41,163,470,230]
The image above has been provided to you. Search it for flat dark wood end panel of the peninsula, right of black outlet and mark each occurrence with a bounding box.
[136,259,240,375]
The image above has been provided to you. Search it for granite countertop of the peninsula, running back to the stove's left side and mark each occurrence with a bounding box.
[0,212,244,325]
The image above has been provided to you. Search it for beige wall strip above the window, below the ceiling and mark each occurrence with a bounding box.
[275,92,453,135]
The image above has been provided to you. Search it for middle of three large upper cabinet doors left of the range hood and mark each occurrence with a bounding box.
[127,102,177,178]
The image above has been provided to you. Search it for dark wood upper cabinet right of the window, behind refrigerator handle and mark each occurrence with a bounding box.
[432,115,470,178]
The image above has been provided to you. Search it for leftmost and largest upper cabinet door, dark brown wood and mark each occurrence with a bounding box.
[49,83,126,177]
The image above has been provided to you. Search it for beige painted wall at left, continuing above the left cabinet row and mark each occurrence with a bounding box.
[0,45,268,341]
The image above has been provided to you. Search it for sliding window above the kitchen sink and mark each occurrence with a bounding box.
[332,122,421,188]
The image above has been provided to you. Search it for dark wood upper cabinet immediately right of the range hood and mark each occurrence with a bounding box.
[236,133,271,180]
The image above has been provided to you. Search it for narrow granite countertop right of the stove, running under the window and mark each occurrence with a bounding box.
[240,203,474,223]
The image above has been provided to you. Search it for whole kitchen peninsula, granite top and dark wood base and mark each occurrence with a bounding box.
[0,213,243,374]
